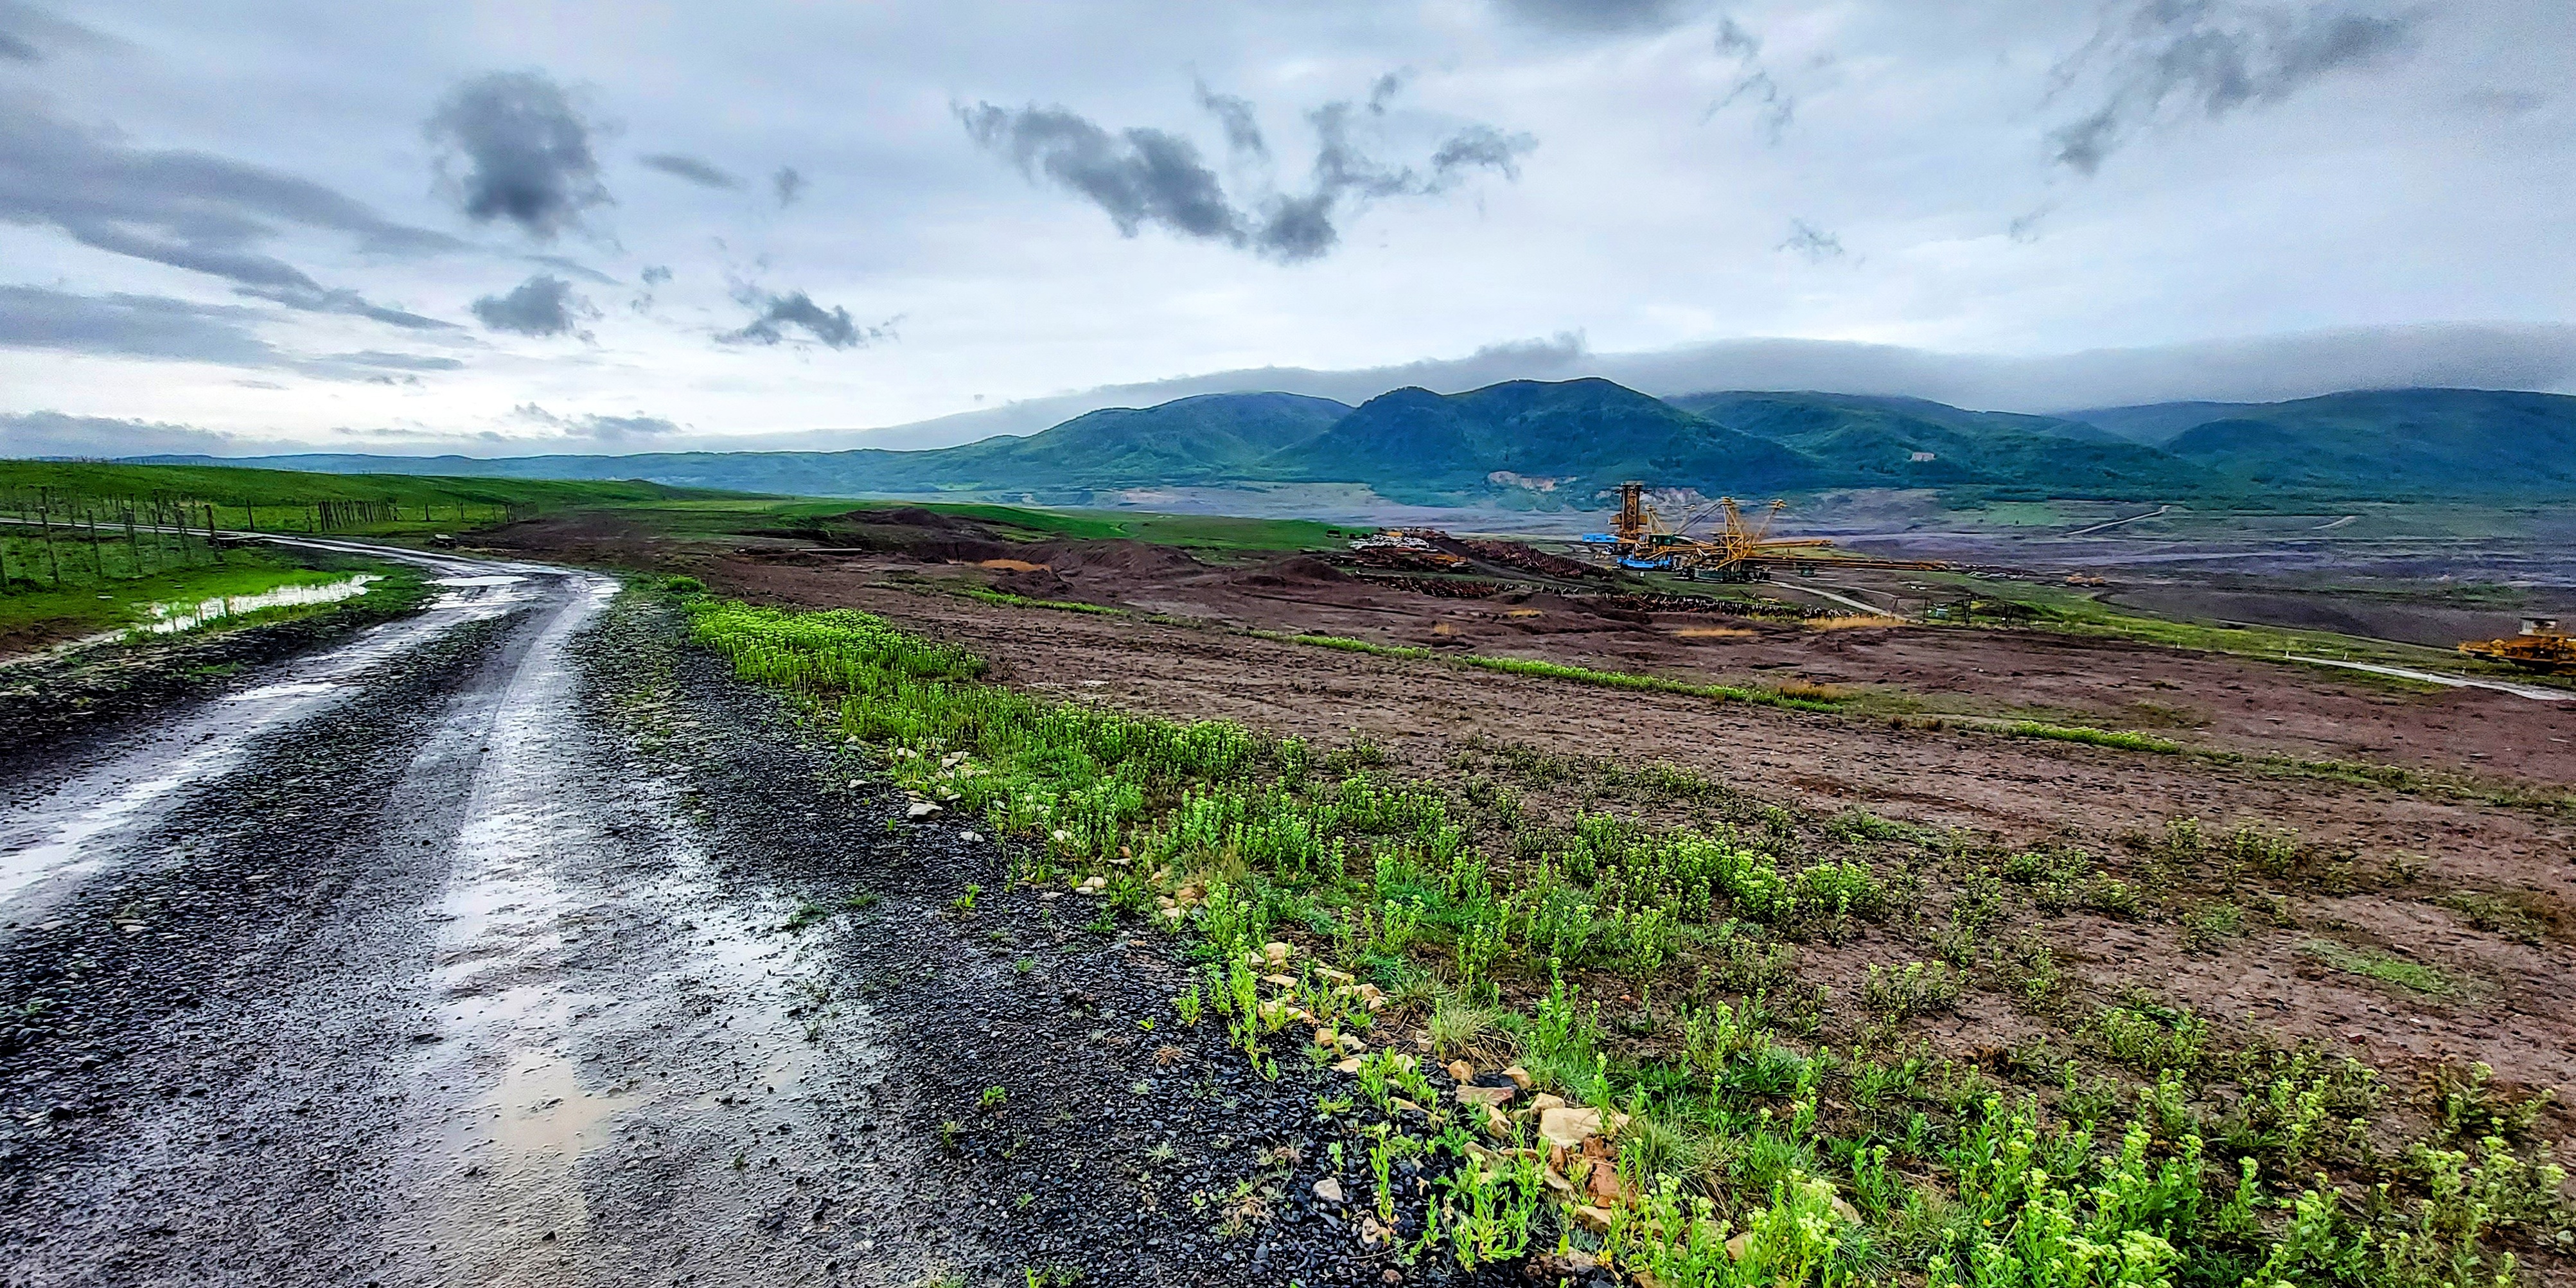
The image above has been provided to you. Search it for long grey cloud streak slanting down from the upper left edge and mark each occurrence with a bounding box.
[0,100,464,319]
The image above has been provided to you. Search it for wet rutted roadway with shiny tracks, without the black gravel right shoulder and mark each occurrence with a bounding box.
[0,554,920,1285]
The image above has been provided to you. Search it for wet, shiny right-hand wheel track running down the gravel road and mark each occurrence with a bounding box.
[389,582,865,1283]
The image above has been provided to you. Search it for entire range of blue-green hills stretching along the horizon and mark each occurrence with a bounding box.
[110,378,2576,507]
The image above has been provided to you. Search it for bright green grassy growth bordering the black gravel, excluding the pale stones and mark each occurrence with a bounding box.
[683,595,2563,1288]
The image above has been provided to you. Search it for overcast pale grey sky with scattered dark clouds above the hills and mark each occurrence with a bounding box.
[0,0,2576,454]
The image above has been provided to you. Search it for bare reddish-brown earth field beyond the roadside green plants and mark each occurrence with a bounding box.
[479,504,2576,1118]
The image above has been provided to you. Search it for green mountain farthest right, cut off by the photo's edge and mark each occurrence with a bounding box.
[2164,389,2576,497]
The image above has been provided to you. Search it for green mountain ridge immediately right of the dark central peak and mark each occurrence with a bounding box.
[1672,394,2221,500]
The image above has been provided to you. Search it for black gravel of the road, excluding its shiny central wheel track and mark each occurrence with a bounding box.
[0,585,1576,1288]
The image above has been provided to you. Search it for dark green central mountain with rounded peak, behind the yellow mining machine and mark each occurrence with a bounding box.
[1265,378,1829,502]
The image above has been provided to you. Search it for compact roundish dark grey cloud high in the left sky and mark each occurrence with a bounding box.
[428,72,610,240]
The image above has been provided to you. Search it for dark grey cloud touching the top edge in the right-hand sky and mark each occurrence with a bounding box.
[2048,0,2424,175]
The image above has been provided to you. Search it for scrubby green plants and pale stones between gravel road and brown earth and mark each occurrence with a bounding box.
[685,595,2571,1288]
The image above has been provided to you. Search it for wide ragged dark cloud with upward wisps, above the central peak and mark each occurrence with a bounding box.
[958,72,1538,263]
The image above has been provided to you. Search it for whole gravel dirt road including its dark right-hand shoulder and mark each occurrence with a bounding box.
[0,546,1452,1285]
